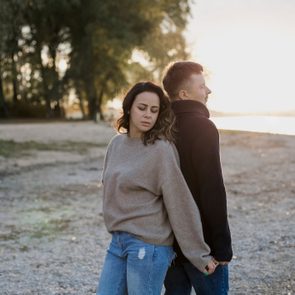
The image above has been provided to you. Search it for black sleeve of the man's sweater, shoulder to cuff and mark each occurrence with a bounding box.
[192,122,232,261]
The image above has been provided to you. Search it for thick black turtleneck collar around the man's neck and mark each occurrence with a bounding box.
[172,100,210,118]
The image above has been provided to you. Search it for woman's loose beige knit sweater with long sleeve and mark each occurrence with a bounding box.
[102,134,211,271]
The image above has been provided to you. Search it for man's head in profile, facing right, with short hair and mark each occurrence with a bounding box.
[163,61,211,104]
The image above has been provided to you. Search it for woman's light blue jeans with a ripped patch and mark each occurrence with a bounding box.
[96,232,174,295]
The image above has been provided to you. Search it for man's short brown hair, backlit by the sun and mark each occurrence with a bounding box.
[163,61,203,100]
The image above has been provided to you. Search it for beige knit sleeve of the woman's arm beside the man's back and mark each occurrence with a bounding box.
[159,143,212,272]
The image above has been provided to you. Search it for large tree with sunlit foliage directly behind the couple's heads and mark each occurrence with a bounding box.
[69,0,189,119]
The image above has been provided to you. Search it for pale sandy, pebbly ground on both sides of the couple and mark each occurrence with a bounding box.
[0,122,295,295]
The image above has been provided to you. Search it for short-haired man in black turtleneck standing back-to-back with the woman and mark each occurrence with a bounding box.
[163,61,232,295]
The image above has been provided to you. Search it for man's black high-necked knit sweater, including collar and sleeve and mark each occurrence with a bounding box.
[172,100,232,262]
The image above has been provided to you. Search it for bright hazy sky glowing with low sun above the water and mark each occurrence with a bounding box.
[186,0,295,114]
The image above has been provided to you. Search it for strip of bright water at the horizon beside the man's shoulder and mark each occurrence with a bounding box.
[211,116,295,135]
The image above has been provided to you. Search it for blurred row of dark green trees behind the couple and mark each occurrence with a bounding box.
[0,0,190,119]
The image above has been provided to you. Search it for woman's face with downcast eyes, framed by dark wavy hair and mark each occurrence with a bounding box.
[129,91,160,137]
